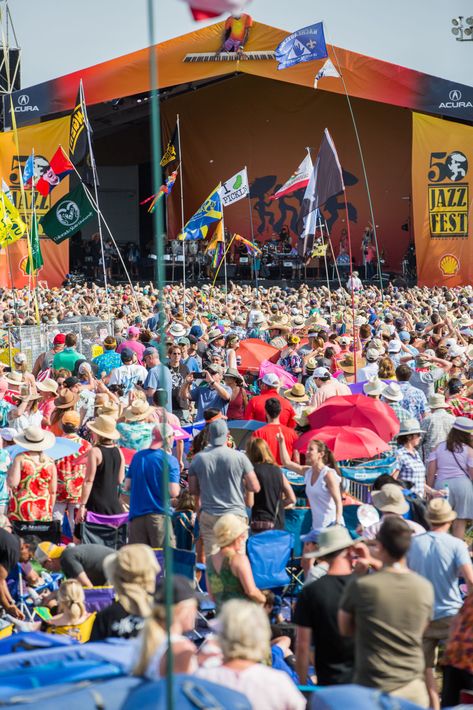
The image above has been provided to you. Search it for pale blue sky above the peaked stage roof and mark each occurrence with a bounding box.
[6,0,473,88]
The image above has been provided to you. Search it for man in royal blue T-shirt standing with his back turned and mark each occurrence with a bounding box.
[125,423,180,548]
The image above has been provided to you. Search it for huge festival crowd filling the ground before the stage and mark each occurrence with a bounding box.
[0,282,473,710]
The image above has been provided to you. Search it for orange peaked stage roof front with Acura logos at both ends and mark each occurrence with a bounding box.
[6,22,473,126]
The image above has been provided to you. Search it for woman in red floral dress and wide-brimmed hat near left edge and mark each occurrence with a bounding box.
[7,427,57,522]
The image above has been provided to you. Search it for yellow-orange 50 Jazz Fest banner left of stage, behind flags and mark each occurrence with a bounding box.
[0,116,69,288]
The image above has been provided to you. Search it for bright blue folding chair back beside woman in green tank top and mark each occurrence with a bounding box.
[246,530,293,589]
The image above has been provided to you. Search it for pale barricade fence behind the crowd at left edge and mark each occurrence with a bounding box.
[0,318,113,370]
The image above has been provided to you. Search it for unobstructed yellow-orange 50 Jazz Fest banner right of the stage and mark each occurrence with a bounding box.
[412,113,473,286]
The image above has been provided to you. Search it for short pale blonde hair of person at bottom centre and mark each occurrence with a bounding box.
[218,599,271,663]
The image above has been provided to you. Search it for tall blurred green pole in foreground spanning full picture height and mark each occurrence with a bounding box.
[148,0,172,710]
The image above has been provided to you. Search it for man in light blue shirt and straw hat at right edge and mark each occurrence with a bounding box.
[407,498,473,708]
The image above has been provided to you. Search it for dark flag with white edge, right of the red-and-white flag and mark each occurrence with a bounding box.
[301,128,345,235]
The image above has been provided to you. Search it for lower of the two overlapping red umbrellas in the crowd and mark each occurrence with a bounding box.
[295,426,389,461]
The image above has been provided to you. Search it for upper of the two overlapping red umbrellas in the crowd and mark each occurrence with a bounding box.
[309,394,400,441]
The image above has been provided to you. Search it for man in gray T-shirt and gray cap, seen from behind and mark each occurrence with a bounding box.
[189,419,260,555]
